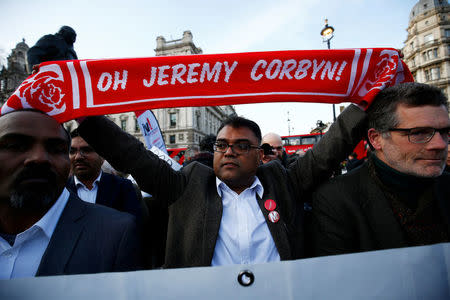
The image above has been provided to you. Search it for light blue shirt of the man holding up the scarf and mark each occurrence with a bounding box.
[211,176,280,266]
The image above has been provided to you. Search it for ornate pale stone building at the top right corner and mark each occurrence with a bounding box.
[402,0,450,97]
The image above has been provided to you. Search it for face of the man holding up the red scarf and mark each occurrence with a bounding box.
[214,126,262,193]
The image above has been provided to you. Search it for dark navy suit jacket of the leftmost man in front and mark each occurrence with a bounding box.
[36,194,142,276]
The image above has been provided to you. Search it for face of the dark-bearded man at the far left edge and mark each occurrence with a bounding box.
[0,111,70,211]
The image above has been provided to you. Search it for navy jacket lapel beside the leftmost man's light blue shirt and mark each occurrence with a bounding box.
[36,195,86,276]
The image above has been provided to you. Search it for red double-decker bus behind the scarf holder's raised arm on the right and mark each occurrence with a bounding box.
[281,133,367,159]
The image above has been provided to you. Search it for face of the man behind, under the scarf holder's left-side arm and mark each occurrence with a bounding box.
[70,136,104,181]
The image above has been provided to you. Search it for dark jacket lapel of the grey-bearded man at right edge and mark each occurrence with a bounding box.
[359,168,407,249]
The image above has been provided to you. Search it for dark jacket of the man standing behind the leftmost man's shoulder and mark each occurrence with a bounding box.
[66,172,146,224]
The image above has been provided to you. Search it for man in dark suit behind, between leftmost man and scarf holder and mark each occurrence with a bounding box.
[67,129,145,223]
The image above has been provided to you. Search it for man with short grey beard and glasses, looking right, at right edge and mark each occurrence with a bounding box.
[312,83,450,255]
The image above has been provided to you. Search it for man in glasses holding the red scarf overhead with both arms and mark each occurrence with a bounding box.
[78,105,366,268]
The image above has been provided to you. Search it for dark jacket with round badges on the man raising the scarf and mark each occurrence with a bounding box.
[78,106,365,267]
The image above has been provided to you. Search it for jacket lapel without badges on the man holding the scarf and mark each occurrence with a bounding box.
[202,176,223,266]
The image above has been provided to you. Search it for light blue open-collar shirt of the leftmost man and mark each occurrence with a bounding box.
[0,189,70,279]
